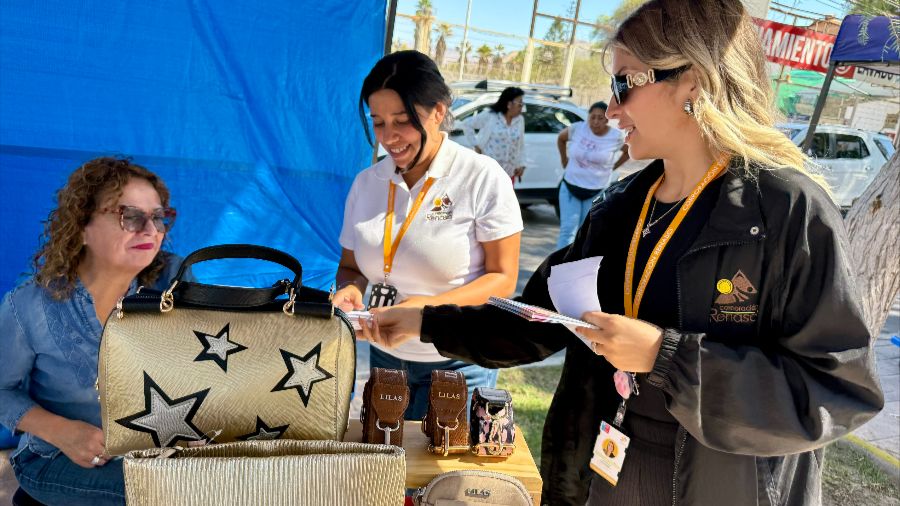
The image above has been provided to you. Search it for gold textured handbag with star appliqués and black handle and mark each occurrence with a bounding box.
[97,245,356,455]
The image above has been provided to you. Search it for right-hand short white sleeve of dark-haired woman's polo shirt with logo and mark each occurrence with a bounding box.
[475,160,524,242]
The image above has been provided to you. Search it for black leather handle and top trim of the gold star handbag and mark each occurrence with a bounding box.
[172,244,303,308]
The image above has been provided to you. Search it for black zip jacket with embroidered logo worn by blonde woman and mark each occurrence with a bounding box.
[422,161,883,505]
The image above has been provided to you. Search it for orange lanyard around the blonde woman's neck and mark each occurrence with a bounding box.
[625,155,731,318]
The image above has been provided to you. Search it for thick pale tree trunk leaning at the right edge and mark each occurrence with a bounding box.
[844,151,900,336]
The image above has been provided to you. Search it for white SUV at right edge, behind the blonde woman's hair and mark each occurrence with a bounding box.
[779,124,894,209]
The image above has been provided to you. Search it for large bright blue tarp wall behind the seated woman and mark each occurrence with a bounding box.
[0,0,385,293]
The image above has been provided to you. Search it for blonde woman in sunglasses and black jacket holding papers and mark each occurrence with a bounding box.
[364,0,883,505]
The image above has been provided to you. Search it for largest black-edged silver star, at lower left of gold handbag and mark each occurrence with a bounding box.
[116,371,209,447]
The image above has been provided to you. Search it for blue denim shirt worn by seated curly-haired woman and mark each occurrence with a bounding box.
[0,255,181,457]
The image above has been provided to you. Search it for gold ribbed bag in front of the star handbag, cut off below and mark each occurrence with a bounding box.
[124,440,406,506]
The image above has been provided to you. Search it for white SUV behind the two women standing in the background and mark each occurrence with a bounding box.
[450,81,588,208]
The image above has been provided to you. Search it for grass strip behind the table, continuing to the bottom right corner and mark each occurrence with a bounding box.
[497,366,900,506]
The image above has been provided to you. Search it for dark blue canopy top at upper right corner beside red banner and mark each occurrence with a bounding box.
[831,14,900,63]
